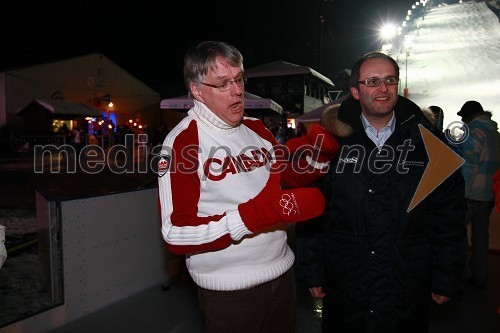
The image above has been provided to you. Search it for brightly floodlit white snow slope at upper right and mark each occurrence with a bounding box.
[395,1,500,127]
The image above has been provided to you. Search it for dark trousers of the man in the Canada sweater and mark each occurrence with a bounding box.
[198,268,296,333]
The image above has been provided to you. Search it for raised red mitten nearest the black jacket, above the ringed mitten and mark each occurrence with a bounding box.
[286,124,340,163]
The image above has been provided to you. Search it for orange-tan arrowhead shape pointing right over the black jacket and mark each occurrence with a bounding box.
[407,124,465,212]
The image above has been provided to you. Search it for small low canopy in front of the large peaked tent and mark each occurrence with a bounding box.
[17,99,102,119]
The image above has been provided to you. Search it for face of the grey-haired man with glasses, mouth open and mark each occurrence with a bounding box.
[191,57,245,126]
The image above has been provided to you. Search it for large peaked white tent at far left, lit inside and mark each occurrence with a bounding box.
[0,53,161,130]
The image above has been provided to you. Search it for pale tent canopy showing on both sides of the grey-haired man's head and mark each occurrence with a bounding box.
[160,92,283,114]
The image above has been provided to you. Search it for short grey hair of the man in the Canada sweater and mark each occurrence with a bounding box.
[184,41,243,91]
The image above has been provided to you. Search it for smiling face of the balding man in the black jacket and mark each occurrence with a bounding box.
[351,58,398,118]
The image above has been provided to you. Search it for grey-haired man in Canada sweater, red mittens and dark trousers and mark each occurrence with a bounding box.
[158,41,339,333]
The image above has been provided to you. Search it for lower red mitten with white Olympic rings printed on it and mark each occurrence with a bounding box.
[238,163,325,232]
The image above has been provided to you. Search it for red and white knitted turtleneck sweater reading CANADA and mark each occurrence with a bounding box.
[158,101,320,291]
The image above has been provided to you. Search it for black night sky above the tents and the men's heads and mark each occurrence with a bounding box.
[0,0,430,97]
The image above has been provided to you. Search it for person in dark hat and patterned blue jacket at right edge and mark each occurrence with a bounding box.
[457,101,500,288]
